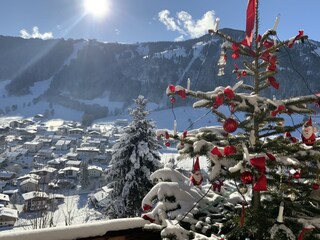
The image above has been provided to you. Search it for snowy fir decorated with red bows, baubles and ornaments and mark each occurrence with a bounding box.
[142,0,320,240]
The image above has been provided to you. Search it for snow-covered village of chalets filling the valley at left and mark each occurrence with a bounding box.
[0,114,128,231]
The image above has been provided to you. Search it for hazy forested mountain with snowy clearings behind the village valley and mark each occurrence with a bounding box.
[0,29,320,123]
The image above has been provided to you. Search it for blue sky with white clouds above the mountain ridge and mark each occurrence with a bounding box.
[0,0,320,43]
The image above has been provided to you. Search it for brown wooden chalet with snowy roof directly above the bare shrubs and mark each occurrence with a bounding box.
[22,191,48,211]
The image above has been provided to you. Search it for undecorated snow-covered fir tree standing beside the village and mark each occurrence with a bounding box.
[106,96,161,218]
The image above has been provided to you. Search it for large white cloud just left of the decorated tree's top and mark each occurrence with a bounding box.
[158,10,215,40]
